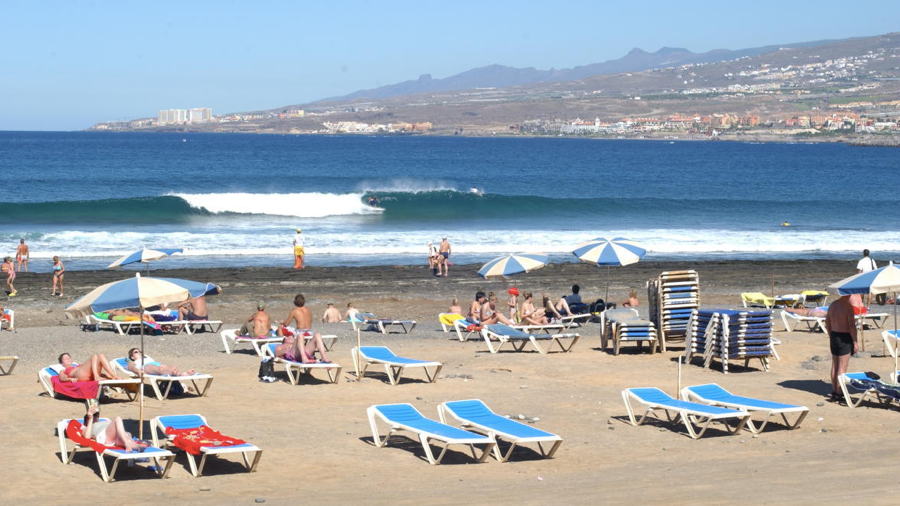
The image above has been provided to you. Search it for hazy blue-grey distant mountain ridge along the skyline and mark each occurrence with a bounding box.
[318,39,853,102]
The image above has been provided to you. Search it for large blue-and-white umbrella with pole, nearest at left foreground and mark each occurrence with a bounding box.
[65,273,221,438]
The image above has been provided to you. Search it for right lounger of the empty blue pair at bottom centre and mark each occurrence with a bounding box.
[438,399,563,462]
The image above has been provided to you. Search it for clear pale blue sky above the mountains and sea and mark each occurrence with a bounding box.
[0,0,900,130]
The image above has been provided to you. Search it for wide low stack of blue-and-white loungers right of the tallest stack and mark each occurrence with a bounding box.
[685,309,777,374]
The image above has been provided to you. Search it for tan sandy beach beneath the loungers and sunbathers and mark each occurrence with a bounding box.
[0,261,900,504]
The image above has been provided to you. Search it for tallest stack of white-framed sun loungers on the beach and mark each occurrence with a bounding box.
[647,270,700,351]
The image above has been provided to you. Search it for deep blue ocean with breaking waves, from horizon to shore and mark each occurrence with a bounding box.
[0,132,900,271]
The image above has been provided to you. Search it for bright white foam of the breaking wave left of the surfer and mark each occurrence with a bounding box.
[171,193,379,218]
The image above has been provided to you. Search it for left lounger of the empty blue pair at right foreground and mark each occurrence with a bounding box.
[622,387,750,439]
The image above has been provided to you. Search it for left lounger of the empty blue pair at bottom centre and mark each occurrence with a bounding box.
[366,404,497,465]
